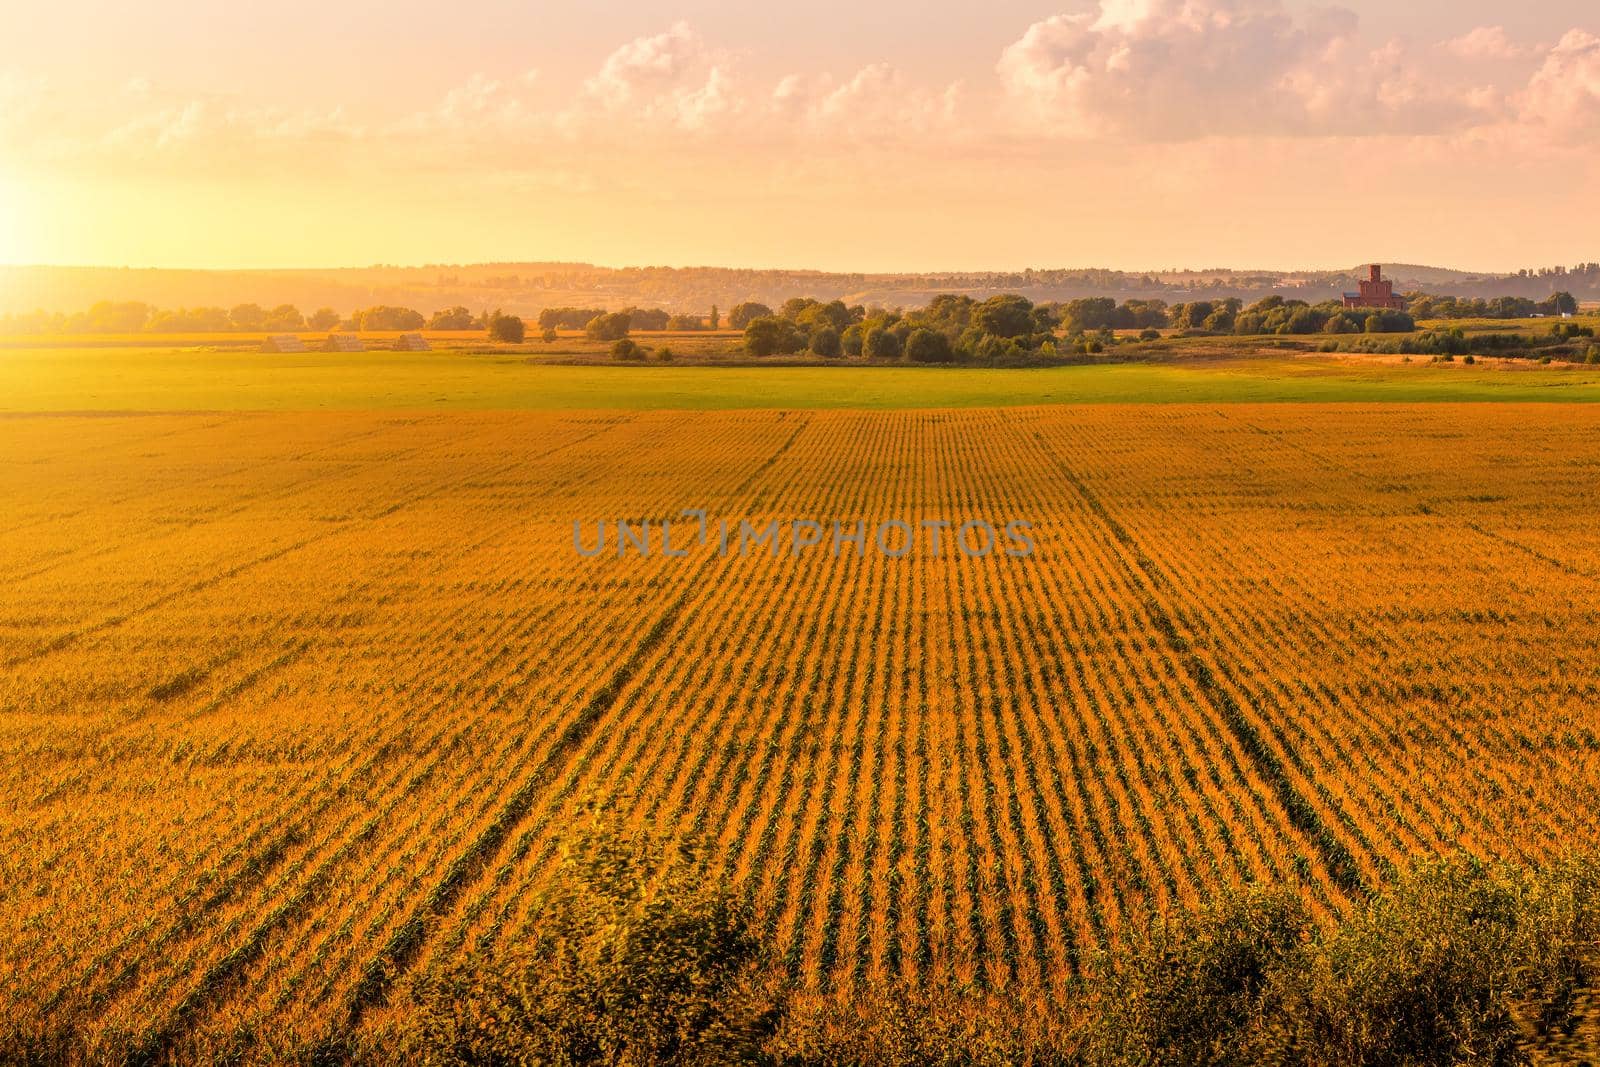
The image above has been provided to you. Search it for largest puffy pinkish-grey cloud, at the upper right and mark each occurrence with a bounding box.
[997,0,1517,141]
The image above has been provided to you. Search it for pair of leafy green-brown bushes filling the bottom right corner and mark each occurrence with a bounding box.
[1086,859,1600,1067]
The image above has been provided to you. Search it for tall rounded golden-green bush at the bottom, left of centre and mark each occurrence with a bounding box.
[400,829,779,1065]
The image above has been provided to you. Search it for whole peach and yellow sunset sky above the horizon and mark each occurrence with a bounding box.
[0,0,1600,270]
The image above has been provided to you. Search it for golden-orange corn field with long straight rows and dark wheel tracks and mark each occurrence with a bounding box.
[0,403,1600,1061]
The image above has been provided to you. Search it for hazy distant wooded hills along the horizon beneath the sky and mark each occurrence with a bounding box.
[0,262,1600,315]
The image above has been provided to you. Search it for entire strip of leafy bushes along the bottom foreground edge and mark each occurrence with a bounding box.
[368,857,1600,1067]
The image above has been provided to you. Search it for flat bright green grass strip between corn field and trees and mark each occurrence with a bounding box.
[0,347,1600,413]
